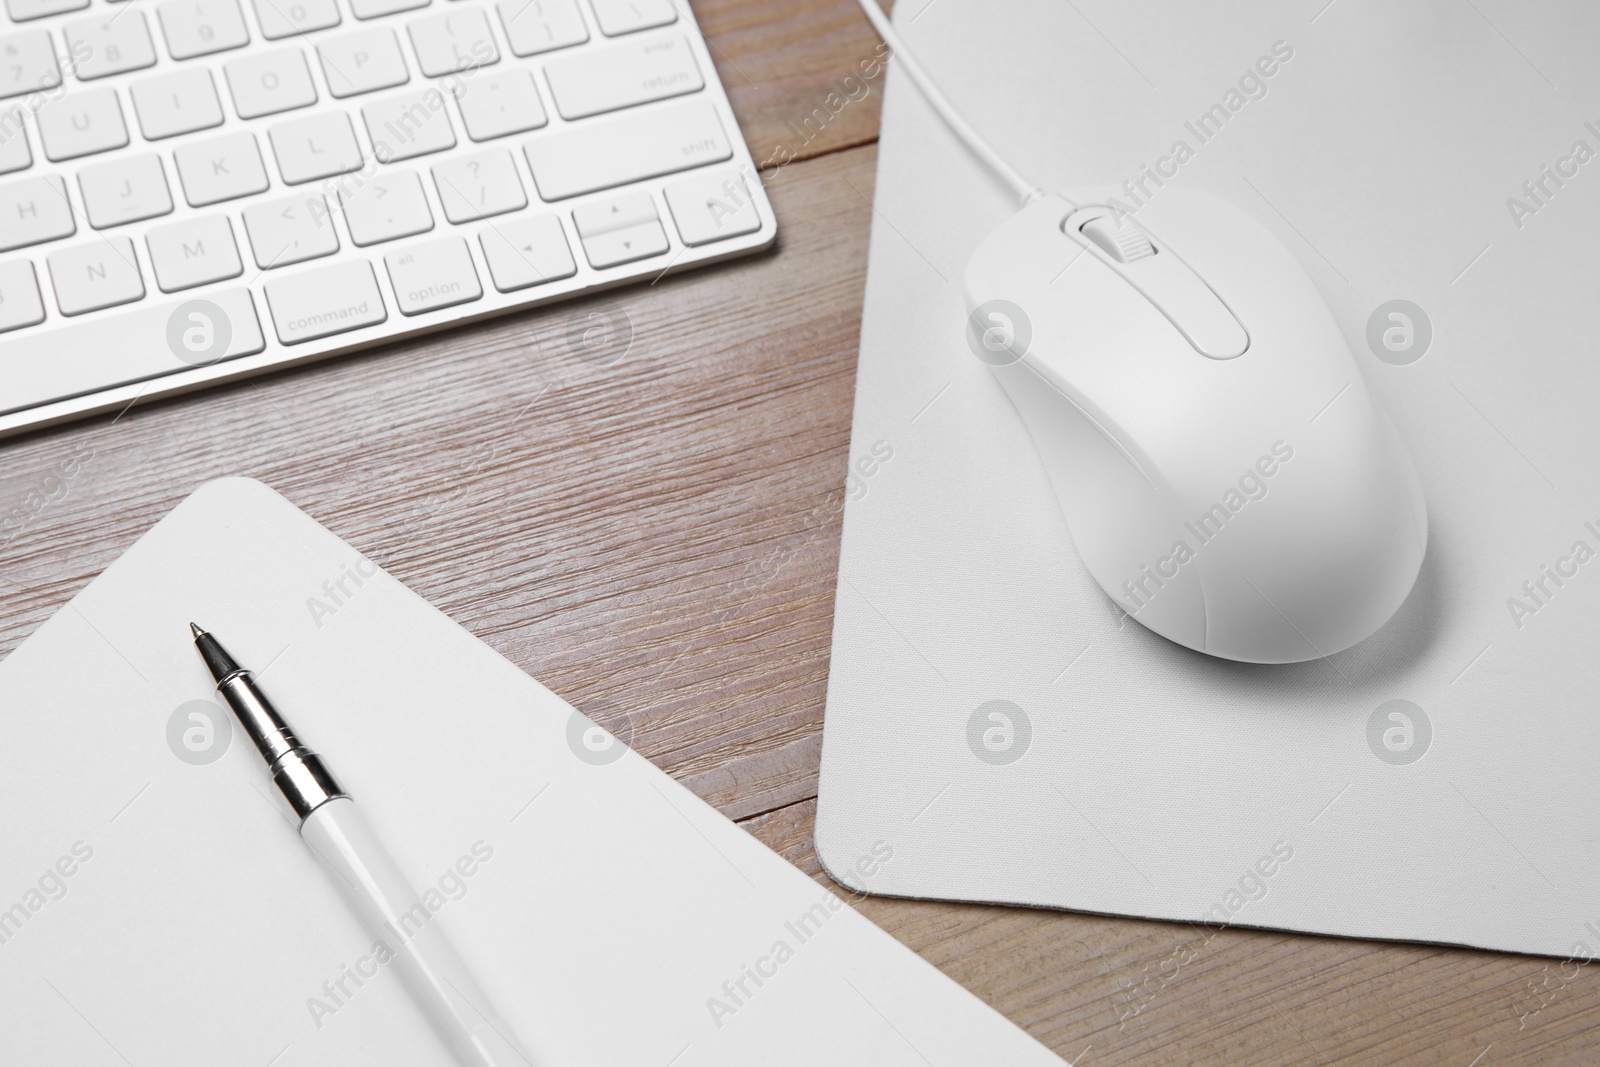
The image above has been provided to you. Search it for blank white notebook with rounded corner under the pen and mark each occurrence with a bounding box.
[0,478,1061,1067]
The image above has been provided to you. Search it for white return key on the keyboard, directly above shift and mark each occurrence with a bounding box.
[544,37,706,118]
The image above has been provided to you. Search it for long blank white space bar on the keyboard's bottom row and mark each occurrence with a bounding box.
[0,290,267,411]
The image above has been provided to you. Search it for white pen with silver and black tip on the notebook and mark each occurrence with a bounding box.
[189,622,533,1067]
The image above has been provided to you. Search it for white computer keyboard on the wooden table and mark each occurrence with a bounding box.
[0,0,778,434]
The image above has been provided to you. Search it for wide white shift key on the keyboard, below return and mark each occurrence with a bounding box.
[523,99,733,200]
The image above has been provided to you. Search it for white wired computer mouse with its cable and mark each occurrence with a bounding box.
[861,0,1427,664]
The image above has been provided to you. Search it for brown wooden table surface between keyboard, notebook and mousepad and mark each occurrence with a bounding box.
[0,0,1600,1067]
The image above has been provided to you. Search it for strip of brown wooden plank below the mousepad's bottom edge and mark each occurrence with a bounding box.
[744,801,1597,1067]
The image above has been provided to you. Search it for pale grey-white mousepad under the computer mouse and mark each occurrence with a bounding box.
[818,0,1600,958]
